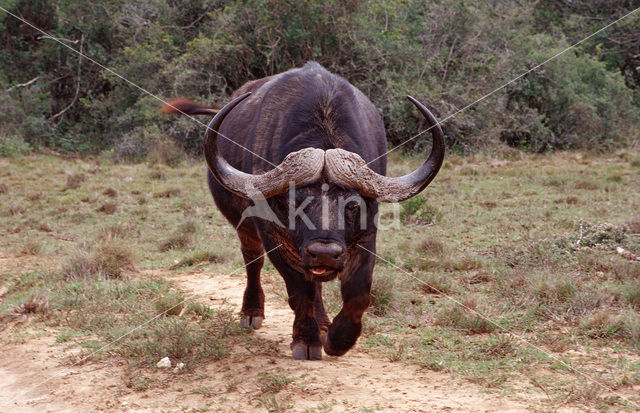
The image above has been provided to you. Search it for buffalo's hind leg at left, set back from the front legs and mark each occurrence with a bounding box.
[238,220,264,330]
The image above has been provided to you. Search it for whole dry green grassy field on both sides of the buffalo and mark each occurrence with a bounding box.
[0,152,640,410]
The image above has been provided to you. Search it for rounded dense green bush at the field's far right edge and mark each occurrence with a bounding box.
[501,34,639,152]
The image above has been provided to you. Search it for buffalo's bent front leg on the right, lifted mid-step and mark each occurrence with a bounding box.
[321,253,373,356]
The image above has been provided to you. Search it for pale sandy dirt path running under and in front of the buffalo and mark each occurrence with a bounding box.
[0,271,527,412]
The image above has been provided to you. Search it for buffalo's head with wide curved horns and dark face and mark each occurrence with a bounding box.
[204,93,444,281]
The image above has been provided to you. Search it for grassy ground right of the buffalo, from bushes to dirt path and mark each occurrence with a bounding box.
[364,153,640,405]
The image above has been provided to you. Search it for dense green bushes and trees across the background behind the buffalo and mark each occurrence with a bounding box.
[0,0,640,161]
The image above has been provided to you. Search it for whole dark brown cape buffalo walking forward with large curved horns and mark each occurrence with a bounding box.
[163,62,445,360]
